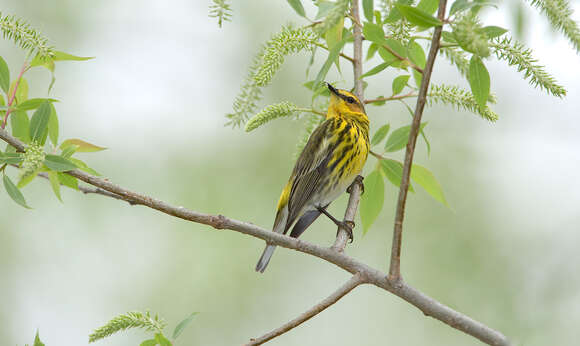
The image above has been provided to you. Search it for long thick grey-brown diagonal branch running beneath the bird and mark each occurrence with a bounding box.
[0,129,509,346]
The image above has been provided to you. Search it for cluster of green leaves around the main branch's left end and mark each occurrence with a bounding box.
[0,45,99,208]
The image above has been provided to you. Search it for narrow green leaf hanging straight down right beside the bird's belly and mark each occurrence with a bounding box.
[360,169,385,234]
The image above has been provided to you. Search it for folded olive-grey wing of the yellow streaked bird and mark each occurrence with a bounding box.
[285,119,333,231]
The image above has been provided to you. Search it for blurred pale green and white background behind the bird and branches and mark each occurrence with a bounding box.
[0,0,580,346]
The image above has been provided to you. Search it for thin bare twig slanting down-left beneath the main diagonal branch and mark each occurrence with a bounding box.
[245,273,364,346]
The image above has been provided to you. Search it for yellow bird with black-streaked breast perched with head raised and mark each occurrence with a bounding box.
[256,83,370,273]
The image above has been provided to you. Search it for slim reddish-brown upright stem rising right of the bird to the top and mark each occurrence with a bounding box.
[389,0,447,281]
